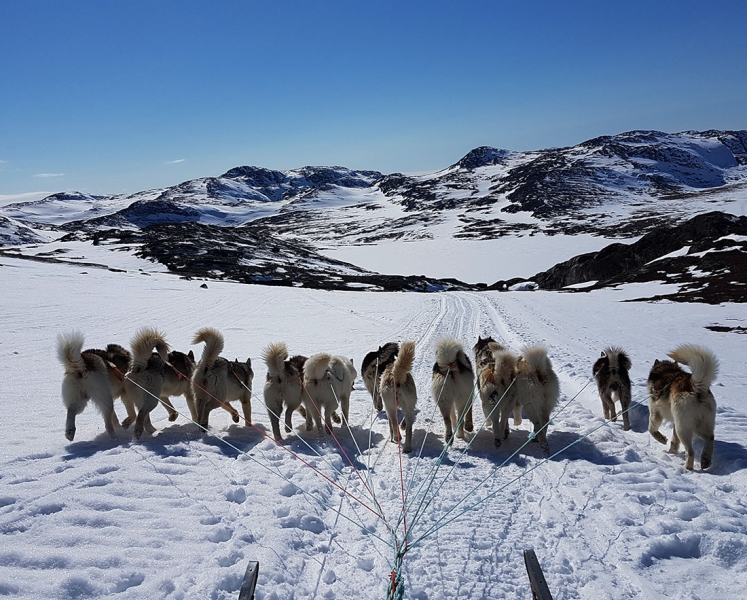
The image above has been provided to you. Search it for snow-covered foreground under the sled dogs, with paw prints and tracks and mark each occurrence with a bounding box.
[0,259,747,600]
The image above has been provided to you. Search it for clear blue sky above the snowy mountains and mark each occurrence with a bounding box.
[0,0,747,201]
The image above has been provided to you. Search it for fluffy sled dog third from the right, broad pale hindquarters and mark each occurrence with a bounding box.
[509,346,560,454]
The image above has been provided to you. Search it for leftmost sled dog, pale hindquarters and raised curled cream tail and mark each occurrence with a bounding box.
[57,331,130,442]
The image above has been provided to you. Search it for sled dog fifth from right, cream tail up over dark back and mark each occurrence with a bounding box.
[431,338,475,442]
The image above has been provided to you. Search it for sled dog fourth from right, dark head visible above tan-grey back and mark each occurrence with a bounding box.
[473,337,521,448]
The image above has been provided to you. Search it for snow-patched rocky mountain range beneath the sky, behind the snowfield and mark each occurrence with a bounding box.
[0,130,747,295]
